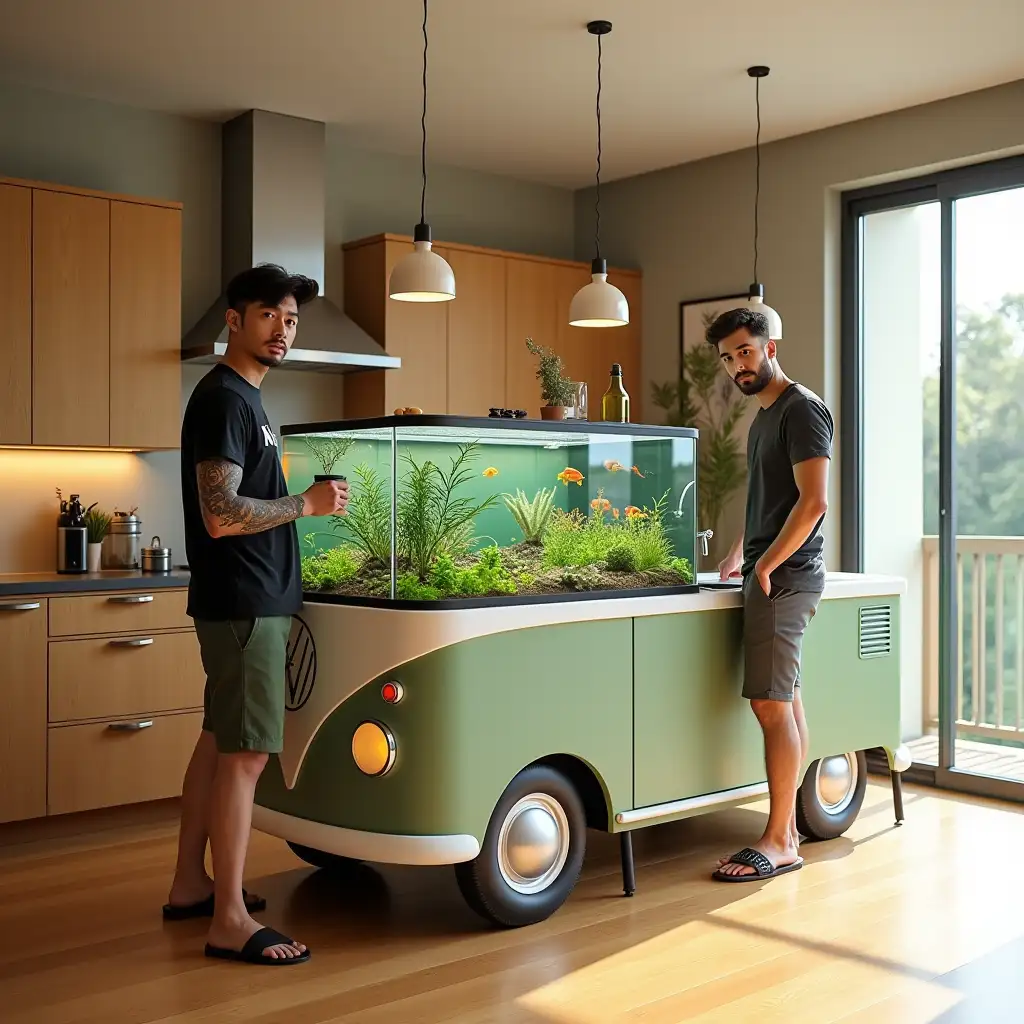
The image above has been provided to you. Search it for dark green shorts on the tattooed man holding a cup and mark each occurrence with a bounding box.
[196,615,292,754]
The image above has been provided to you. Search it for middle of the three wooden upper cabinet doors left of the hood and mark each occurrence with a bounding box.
[32,188,111,447]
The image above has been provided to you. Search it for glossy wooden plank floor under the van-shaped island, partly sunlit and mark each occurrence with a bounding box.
[0,778,1024,1024]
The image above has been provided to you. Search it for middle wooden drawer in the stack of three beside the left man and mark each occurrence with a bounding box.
[49,631,206,723]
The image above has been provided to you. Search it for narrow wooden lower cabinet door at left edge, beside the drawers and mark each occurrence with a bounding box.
[0,598,46,822]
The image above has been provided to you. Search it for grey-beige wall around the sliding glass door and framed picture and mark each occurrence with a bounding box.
[575,81,1024,566]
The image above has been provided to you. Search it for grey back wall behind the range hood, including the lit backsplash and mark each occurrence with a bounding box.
[0,83,573,571]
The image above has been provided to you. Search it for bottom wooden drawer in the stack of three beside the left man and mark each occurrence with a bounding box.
[46,712,203,814]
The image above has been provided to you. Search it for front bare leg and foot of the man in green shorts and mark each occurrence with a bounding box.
[208,753,306,958]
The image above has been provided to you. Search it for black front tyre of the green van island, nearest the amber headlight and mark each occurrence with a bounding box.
[455,765,587,928]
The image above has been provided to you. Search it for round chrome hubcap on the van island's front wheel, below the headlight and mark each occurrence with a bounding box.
[498,793,569,895]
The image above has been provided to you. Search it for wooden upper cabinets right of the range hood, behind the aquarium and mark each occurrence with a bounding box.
[344,234,643,422]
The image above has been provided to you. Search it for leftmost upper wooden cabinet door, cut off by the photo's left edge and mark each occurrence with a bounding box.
[0,185,32,444]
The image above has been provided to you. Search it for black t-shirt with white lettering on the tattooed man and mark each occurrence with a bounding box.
[181,364,302,621]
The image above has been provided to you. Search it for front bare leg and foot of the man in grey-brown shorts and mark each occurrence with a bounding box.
[721,700,801,874]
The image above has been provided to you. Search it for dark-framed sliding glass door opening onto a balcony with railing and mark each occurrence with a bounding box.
[842,153,1024,800]
